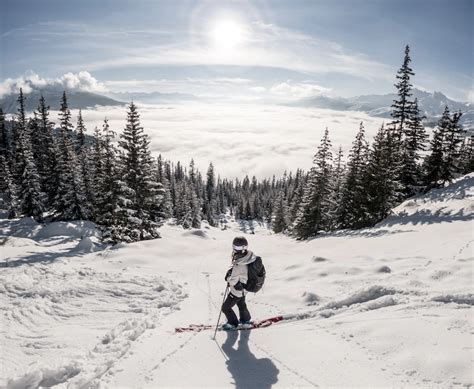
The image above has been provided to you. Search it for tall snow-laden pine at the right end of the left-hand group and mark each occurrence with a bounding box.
[119,102,163,239]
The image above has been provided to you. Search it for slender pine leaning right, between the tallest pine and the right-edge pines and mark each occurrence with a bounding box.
[424,106,451,191]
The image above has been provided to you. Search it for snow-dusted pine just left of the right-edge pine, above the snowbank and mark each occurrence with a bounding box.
[441,112,464,184]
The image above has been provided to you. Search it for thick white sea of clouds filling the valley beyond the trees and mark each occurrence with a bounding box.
[43,102,383,178]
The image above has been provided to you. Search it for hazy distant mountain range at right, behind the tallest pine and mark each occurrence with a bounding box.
[290,88,474,127]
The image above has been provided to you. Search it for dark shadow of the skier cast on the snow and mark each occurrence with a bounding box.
[222,331,280,389]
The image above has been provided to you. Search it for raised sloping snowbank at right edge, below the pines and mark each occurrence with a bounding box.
[377,173,474,227]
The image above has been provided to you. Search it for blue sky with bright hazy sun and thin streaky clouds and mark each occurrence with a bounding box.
[0,0,474,100]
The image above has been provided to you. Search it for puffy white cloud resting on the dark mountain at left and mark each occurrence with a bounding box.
[0,71,107,97]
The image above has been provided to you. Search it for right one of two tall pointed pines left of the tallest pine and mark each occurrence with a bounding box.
[337,122,369,229]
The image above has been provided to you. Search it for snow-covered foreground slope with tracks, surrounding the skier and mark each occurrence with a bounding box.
[0,174,474,388]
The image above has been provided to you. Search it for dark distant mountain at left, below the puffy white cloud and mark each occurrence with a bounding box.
[0,86,125,113]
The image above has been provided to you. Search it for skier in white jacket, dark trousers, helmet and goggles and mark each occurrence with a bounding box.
[222,236,257,330]
